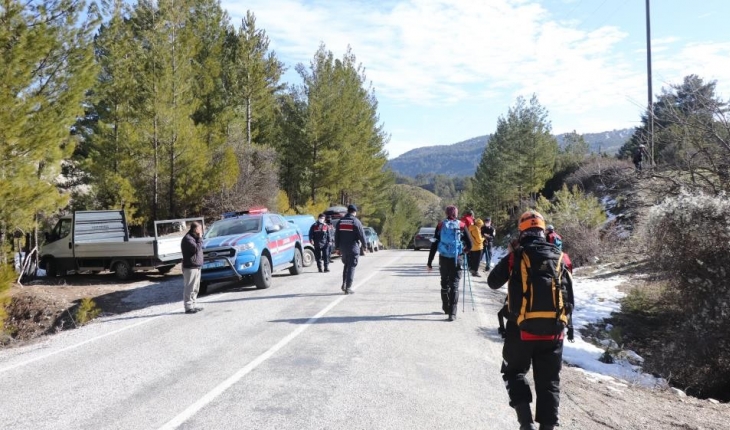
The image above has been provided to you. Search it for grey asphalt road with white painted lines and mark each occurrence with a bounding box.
[0,251,516,430]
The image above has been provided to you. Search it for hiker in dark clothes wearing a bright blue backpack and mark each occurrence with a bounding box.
[426,206,472,321]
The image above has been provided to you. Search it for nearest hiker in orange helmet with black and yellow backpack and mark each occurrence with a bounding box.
[487,211,574,430]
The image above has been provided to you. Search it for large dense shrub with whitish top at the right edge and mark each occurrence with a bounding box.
[645,193,730,400]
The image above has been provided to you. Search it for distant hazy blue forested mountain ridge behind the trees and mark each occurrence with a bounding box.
[388,128,634,177]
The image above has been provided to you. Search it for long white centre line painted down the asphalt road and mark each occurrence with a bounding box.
[159,255,402,430]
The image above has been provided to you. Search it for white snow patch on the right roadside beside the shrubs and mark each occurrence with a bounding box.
[563,277,666,387]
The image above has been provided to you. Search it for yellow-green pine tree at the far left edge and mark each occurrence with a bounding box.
[0,0,98,254]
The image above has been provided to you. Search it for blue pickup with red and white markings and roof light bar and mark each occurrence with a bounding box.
[200,207,303,294]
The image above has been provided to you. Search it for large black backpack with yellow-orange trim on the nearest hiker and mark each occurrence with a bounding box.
[507,242,569,336]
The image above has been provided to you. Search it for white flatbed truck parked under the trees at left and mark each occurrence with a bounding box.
[40,210,203,280]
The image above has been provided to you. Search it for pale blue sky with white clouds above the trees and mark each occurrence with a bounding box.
[222,0,730,158]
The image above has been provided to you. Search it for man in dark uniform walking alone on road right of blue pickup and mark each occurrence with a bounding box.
[335,205,366,294]
